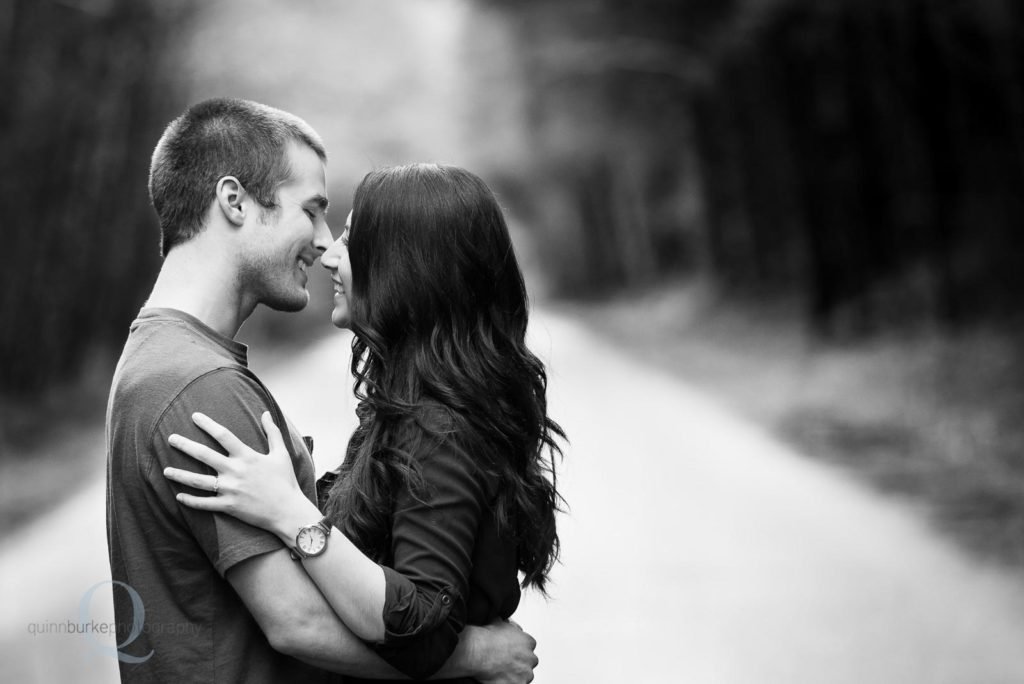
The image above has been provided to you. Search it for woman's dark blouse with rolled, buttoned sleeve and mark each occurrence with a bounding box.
[317,413,519,682]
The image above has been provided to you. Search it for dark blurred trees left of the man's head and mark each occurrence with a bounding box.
[0,0,187,395]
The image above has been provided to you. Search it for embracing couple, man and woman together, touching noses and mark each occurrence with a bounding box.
[106,99,563,682]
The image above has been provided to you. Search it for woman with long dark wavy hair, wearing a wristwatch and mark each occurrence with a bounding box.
[166,165,564,678]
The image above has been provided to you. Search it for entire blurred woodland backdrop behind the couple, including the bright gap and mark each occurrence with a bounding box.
[8,0,1024,395]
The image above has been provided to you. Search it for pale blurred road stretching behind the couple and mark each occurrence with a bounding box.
[6,312,1024,684]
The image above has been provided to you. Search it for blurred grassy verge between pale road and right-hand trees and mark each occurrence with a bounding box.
[561,284,1024,568]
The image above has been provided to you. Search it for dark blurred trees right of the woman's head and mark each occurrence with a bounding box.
[484,0,1024,334]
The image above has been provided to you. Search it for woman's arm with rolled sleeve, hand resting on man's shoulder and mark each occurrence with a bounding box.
[166,415,483,677]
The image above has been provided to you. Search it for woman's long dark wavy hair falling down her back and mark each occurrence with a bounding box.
[327,165,565,592]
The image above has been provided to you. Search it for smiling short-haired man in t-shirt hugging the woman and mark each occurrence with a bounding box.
[106,99,537,682]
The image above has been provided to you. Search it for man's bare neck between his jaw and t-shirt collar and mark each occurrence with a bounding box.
[145,239,256,338]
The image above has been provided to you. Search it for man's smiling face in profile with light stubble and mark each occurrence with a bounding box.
[240,142,332,311]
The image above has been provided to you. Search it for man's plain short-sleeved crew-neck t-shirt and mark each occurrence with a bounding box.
[106,308,329,682]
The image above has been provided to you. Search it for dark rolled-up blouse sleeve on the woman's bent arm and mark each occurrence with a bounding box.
[375,438,487,679]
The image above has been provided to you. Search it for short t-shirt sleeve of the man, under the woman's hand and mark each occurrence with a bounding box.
[144,369,295,576]
